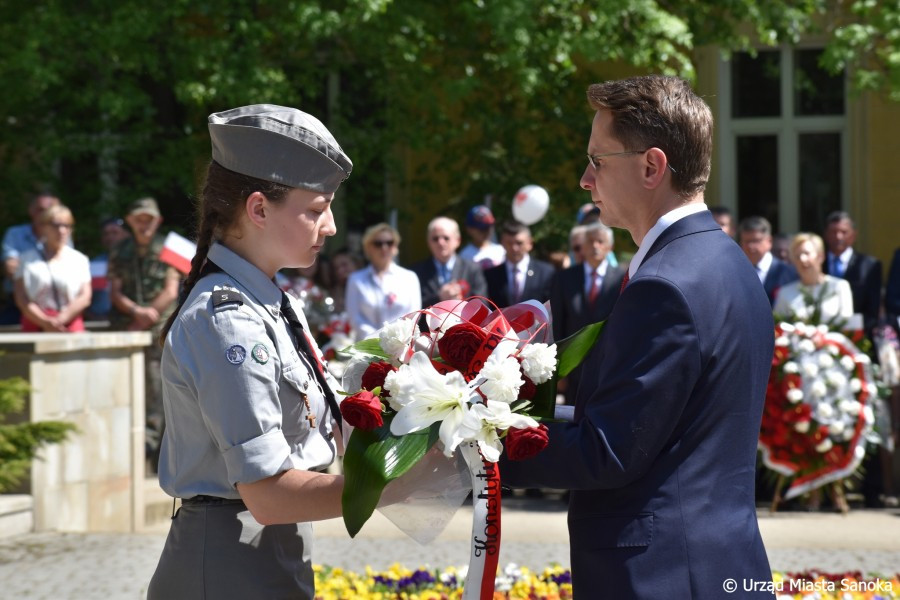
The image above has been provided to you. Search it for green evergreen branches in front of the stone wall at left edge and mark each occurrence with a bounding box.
[0,377,75,492]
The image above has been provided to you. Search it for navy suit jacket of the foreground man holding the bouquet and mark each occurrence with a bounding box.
[500,212,774,600]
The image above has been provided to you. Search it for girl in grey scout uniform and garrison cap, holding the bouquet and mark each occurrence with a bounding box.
[148,105,352,600]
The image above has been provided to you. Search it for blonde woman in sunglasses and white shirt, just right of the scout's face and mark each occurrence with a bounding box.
[345,223,422,340]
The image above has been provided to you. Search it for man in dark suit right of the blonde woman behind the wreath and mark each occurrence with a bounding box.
[823,211,881,339]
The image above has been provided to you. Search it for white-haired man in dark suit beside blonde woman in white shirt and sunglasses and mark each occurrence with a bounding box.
[412,217,487,308]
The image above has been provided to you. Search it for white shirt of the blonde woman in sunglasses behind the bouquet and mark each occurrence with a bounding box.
[344,263,422,341]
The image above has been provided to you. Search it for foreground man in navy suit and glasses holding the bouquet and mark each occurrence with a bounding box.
[500,76,774,600]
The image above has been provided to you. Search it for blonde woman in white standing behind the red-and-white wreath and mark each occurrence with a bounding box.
[774,233,853,327]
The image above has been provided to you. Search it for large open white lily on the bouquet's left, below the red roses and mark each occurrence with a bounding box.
[384,352,473,448]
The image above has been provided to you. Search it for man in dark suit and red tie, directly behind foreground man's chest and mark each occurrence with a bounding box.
[550,222,625,404]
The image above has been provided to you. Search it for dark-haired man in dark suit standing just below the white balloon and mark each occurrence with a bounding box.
[484,221,556,308]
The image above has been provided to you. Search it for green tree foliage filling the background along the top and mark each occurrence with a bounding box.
[0,0,900,254]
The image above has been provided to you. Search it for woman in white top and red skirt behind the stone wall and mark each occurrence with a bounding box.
[13,204,91,332]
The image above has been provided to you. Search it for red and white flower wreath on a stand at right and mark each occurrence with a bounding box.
[759,323,878,499]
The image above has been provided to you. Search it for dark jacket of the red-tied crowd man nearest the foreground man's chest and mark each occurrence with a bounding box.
[550,264,625,404]
